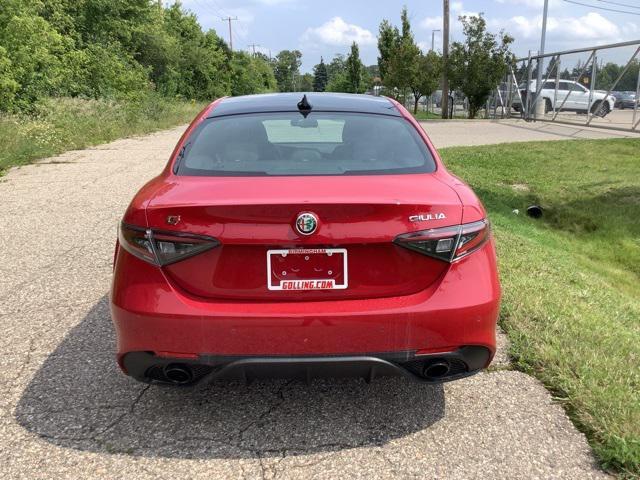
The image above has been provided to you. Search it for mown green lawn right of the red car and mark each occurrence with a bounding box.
[441,139,640,476]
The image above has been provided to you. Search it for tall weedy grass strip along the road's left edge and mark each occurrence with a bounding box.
[0,95,203,175]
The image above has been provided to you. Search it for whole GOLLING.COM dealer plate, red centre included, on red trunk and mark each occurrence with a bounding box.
[267,248,347,291]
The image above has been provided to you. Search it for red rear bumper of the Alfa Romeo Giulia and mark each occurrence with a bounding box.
[111,242,500,378]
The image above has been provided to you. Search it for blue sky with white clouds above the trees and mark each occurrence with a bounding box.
[175,0,640,72]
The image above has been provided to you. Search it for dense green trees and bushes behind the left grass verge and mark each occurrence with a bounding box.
[0,0,274,112]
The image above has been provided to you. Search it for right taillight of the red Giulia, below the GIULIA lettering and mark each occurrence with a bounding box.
[394,220,491,262]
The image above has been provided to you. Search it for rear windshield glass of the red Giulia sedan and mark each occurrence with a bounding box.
[177,112,435,176]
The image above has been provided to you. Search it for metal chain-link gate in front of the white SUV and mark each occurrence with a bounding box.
[486,40,640,131]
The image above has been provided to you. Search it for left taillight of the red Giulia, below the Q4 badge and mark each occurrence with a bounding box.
[118,223,220,266]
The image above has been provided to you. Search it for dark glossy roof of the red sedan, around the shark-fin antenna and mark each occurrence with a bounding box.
[208,92,401,118]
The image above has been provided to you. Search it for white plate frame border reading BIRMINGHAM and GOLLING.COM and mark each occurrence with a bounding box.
[267,248,349,292]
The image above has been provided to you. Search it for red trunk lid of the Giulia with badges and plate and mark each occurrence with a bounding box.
[147,174,462,301]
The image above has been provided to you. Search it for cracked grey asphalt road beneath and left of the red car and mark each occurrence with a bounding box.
[0,123,606,479]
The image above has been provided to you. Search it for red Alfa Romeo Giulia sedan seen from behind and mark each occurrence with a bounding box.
[111,93,500,385]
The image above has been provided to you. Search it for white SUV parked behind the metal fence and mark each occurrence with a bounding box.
[513,80,615,117]
